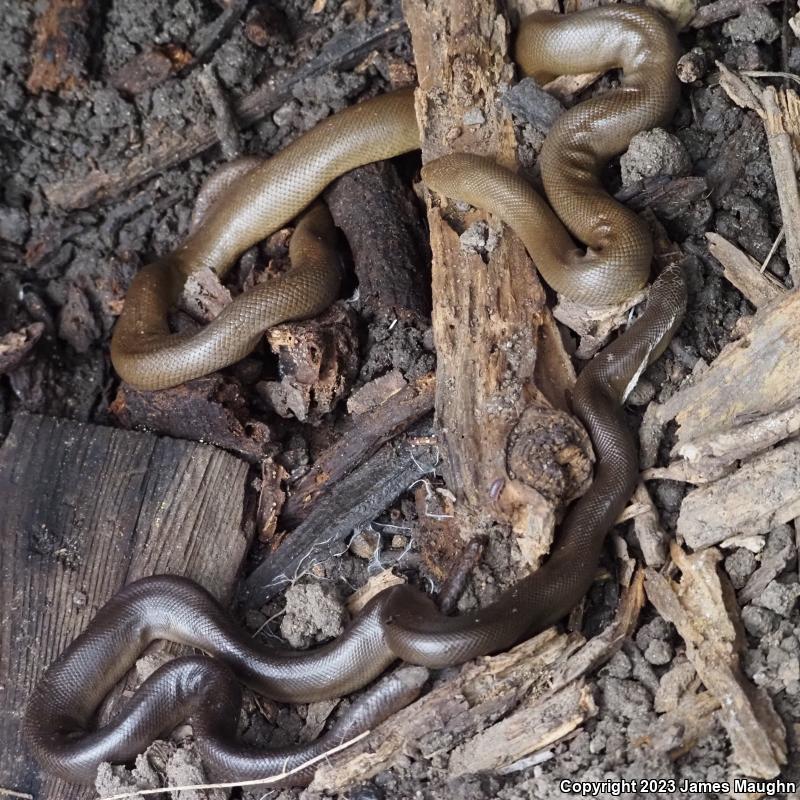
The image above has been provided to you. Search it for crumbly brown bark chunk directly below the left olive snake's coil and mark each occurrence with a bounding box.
[256,303,358,422]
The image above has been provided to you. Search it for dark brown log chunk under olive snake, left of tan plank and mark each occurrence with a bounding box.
[325,161,431,320]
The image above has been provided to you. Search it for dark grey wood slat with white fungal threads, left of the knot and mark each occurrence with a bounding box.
[242,434,436,607]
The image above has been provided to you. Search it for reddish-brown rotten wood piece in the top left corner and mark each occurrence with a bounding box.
[27,0,95,94]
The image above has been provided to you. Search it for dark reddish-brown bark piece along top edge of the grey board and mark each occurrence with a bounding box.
[109,375,272,462]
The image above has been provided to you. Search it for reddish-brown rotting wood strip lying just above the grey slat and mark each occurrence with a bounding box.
[281,374,436,528]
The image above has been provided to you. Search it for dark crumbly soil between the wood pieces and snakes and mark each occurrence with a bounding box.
[0,0,800,800]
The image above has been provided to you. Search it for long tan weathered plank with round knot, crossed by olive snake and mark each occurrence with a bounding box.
[404,0,589,555]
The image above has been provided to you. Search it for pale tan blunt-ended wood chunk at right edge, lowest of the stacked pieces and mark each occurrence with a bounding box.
[678,440,800,549]
